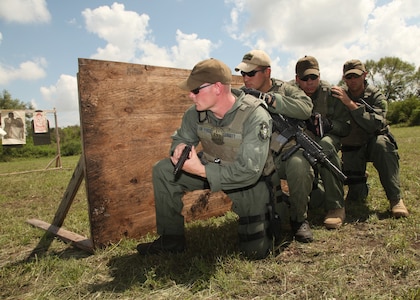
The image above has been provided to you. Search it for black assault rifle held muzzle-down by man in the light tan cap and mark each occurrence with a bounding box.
[242,88,347,181]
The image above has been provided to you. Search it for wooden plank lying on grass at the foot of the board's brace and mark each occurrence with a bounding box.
[26,219,93,253]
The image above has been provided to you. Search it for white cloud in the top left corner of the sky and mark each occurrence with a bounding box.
[0,0,51,23]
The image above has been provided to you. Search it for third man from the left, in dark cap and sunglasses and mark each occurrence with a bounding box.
[288,56,350,229]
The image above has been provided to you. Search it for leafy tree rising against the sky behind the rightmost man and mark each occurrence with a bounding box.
[365,57,419,102]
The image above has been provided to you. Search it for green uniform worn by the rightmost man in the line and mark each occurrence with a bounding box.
[342,82,401,202]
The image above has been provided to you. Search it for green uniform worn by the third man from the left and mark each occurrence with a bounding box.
[293,80,350,210]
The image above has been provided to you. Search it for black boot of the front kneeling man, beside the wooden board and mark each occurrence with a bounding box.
[137,235,185,255]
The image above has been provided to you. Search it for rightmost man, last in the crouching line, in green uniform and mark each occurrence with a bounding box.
[331,59,409,218]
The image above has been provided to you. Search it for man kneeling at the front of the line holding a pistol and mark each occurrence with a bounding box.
[137,59,274,259]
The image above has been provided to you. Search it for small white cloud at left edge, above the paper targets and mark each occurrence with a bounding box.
[0,58,46,85]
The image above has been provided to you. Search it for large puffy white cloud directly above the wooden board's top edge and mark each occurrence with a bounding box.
[82,3,217,68]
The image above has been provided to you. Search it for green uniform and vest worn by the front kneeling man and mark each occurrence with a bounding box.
[153,89,272,258]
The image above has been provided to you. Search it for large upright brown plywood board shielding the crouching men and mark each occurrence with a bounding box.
[78,59,242,247]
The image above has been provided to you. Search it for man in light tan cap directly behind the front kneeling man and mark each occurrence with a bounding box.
[235,50,314,243]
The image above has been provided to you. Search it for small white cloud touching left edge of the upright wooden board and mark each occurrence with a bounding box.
[40,74,79,112]
